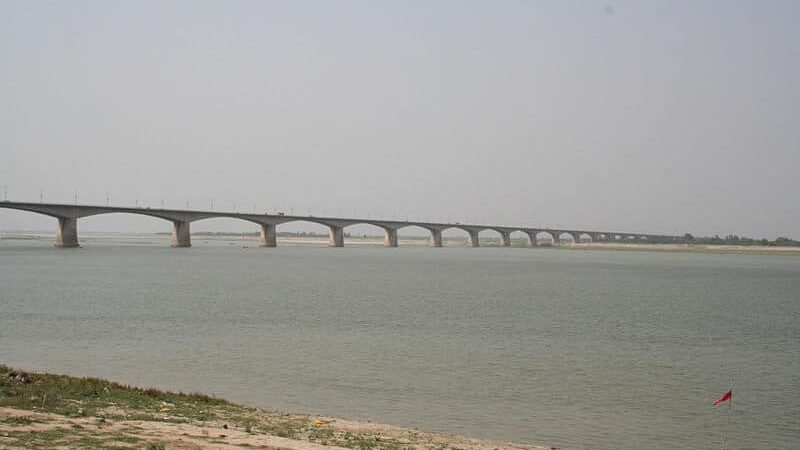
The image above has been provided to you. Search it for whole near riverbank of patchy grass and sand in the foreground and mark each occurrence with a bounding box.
[0,365,554,450]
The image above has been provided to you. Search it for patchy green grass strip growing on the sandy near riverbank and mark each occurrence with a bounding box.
[0,364,438,450]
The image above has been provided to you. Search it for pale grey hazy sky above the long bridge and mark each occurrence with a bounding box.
[0,1,800,238]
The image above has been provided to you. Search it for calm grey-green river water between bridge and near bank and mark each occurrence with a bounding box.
[0,237,800,450]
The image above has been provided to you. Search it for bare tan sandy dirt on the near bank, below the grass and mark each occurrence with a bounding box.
[0,408,544,450]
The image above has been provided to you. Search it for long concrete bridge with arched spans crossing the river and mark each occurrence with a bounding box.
[0,201,681,247]
